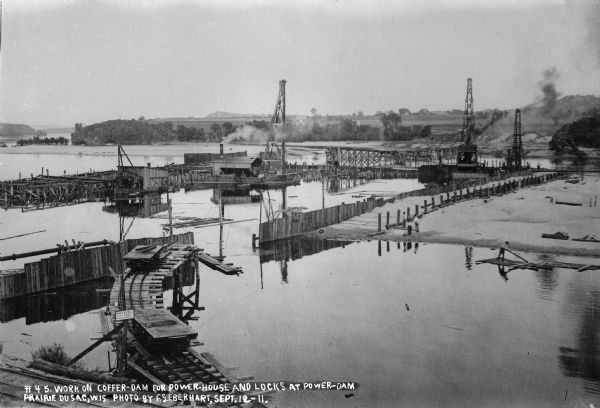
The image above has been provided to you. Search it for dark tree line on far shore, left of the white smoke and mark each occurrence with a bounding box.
[71,118,235,145]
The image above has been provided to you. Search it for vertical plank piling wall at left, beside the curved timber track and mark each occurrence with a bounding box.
[0,232,194,299]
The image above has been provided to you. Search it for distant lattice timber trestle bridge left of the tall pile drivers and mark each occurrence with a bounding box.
[325,147,456,168]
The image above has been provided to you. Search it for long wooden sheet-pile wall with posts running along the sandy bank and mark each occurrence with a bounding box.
[258,171,555,244]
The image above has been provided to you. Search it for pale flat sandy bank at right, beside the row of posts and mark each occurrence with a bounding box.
[319,175,600,257]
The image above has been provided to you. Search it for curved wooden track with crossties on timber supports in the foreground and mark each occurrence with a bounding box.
[103,244,264,407]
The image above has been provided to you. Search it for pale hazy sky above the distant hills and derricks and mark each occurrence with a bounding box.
[0,0,600,126]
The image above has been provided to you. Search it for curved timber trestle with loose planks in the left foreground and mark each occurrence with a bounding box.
[100,243,264,407]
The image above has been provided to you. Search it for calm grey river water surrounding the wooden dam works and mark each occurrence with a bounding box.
[0,147,600,407]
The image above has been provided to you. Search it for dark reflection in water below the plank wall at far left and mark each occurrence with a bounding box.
[0,278,112,325]
